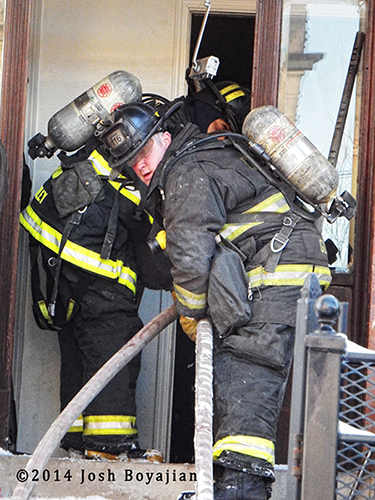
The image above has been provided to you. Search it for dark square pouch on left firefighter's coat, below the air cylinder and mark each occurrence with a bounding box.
[52,160,104,218]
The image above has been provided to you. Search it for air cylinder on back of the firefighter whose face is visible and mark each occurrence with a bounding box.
[242,106,339,204]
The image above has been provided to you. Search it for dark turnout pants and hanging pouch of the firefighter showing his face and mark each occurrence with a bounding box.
[208,245,300,488]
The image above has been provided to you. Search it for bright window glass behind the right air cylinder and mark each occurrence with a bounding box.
[278,0,366,273]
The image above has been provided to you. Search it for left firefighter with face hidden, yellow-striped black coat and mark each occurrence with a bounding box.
[21,117,173,461]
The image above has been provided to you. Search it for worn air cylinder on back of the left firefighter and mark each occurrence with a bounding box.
[44,70,142,156]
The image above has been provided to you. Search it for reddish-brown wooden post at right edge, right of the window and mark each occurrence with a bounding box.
[351,0,375,349]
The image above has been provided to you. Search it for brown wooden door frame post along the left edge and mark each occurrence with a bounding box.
[0,0,31,449]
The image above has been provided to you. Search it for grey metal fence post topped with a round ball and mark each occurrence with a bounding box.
[301,295,346,500]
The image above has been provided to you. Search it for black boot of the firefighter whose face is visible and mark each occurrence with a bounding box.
[214,468,269,500]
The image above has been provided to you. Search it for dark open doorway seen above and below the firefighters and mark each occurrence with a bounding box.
[170,14,255,463]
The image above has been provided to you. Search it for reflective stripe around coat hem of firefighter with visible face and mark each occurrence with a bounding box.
[247,264,332,288]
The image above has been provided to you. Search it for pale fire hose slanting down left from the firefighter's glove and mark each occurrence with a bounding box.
[11,305,178,500]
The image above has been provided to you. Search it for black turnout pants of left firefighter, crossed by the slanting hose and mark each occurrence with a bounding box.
[59,304,142,453]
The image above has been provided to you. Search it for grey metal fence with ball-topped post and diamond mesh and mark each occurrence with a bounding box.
[287,277,375,500]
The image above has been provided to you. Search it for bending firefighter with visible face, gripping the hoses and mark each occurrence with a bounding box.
[100,104,331,500]
